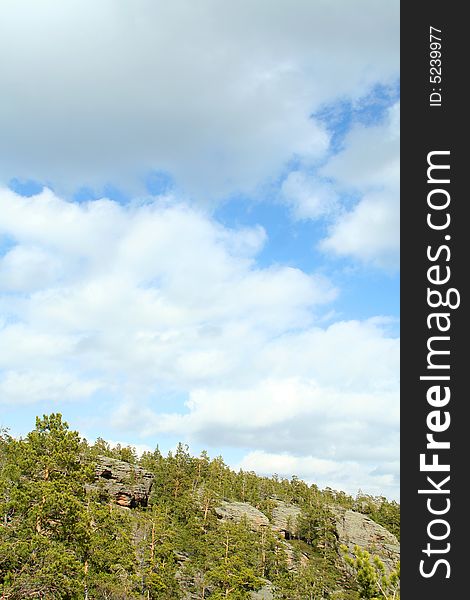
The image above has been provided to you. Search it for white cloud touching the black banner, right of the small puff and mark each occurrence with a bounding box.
[321,103,400,268]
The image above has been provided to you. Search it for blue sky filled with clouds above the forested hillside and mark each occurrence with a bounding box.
[0,0,399,498]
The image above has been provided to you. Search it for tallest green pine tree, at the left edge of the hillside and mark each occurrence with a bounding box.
[1,414,91,599]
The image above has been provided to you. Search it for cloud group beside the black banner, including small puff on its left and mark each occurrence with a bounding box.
[280,102,400,270]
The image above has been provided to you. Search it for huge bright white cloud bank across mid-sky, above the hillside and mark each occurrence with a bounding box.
[0,189,398,486]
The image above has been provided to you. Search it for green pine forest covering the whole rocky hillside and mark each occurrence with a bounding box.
[0,414,400,600]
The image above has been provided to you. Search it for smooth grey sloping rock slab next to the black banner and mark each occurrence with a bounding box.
[332,507,400,569]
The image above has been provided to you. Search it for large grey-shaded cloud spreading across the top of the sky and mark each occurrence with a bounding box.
[0,0,399,197]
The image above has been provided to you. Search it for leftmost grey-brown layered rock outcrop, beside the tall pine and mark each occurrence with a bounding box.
[88,456,154,508]
